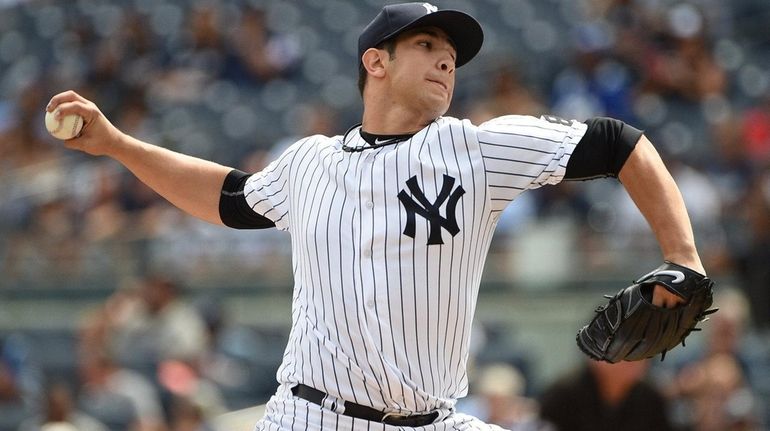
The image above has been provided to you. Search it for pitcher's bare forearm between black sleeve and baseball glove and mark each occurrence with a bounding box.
[619,136,705,274]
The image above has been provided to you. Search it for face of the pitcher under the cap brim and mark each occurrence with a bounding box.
[387,27,457,118]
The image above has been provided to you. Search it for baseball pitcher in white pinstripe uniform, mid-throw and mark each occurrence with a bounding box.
[47,2,711,431]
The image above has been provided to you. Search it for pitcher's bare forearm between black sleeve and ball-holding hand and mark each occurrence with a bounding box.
[107,134,231,224]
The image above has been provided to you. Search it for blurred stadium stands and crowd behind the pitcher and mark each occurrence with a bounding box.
[0,0,770,431]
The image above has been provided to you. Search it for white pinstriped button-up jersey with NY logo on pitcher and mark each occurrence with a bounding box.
[244,116,586,414]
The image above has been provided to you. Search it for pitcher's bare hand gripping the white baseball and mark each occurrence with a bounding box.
[45,90,123,156]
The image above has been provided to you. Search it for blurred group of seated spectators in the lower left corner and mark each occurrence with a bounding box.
[0,274,280,431]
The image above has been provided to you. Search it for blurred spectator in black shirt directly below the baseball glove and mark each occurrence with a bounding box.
[540,360,674,431]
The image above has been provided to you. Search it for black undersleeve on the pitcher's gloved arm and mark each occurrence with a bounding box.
[564,117,642,180]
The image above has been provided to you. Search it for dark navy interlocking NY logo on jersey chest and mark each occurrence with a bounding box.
[398,174,465,245]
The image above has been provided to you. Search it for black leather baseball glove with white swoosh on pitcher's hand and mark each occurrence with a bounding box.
[577,261,717,363]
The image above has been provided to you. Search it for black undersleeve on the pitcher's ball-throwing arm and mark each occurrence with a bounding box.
[219,169,275,229]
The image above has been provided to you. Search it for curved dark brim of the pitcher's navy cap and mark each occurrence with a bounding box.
[383,10,484,67]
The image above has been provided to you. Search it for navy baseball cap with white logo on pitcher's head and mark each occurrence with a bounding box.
[358,2,484,67]
